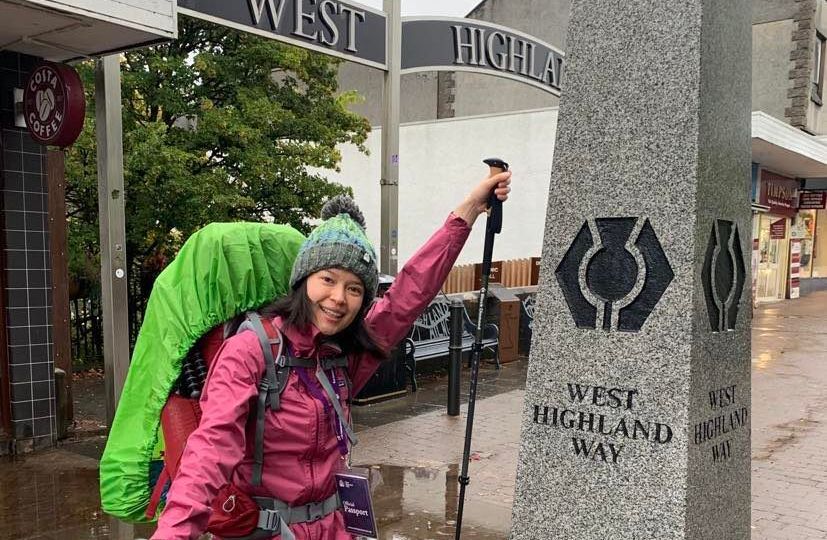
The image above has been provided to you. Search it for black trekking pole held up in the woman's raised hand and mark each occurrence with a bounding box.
[454,158,508,540]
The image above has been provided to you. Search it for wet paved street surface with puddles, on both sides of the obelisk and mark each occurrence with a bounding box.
[0,291,827,540]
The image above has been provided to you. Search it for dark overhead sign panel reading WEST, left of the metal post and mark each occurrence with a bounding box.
[178,0,387,69]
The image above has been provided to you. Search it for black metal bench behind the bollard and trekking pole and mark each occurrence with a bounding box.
[403,297,500,392]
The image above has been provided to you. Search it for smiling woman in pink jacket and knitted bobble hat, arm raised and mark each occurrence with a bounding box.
[153,167,511,540]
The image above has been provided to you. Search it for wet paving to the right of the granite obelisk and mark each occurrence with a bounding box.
[752,291,827,540]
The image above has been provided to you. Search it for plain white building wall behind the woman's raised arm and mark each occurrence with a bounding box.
[324,107,557,268]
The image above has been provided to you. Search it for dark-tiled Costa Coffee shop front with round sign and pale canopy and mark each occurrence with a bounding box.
[0,0,176,455]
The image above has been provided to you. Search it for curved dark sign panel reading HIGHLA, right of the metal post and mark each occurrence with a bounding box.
[402,17,564,96]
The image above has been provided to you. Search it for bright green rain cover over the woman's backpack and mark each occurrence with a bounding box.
[100,223,304,522]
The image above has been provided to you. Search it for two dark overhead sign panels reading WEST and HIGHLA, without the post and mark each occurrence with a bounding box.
[178,0,564,95]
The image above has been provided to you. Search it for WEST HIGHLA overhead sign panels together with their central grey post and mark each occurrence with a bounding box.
[177,0,565,275]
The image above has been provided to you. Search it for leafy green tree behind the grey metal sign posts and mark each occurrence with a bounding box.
[66,17,370,298]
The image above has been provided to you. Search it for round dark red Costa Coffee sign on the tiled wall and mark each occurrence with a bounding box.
[23,64,86,148]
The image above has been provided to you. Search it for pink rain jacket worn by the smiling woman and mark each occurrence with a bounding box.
[152,214,470,540]
